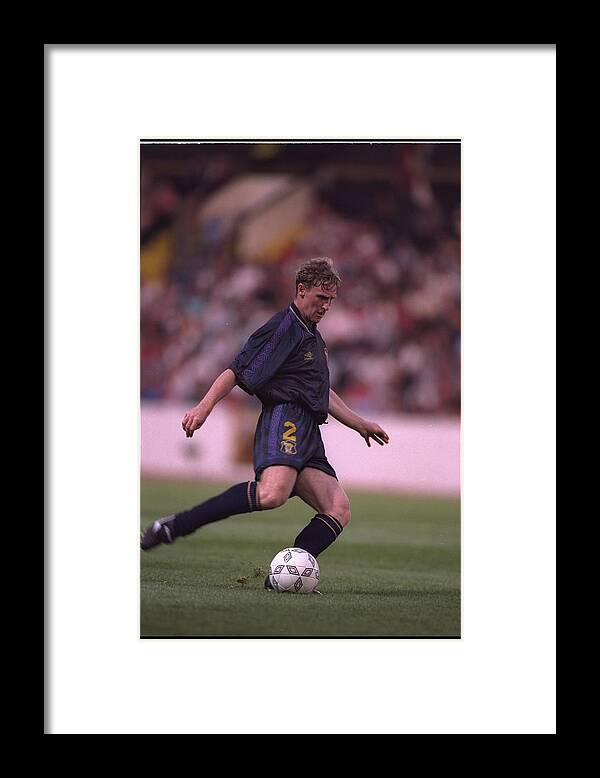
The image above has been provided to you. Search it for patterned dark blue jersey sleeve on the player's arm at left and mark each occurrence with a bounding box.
[229,311,301,394]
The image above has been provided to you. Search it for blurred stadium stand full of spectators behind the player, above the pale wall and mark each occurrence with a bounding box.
[140,143,461,416]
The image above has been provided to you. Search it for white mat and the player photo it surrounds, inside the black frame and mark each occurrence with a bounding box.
[44,44,557,734]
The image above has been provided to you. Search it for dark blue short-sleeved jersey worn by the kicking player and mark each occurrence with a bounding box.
[229,303,329,424]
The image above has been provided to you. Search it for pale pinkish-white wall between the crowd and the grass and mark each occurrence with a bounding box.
[141,402,460,495]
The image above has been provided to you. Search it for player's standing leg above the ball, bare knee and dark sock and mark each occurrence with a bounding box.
[294,467,351,557]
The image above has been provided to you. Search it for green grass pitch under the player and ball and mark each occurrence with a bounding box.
[140,480,460,637]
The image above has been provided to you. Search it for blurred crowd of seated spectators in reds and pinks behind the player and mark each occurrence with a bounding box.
[141,144,460,415]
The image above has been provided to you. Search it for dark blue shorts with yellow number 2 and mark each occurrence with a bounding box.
[254,403,337,481]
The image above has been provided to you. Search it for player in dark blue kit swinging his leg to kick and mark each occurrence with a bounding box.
[140,257,389,589]
